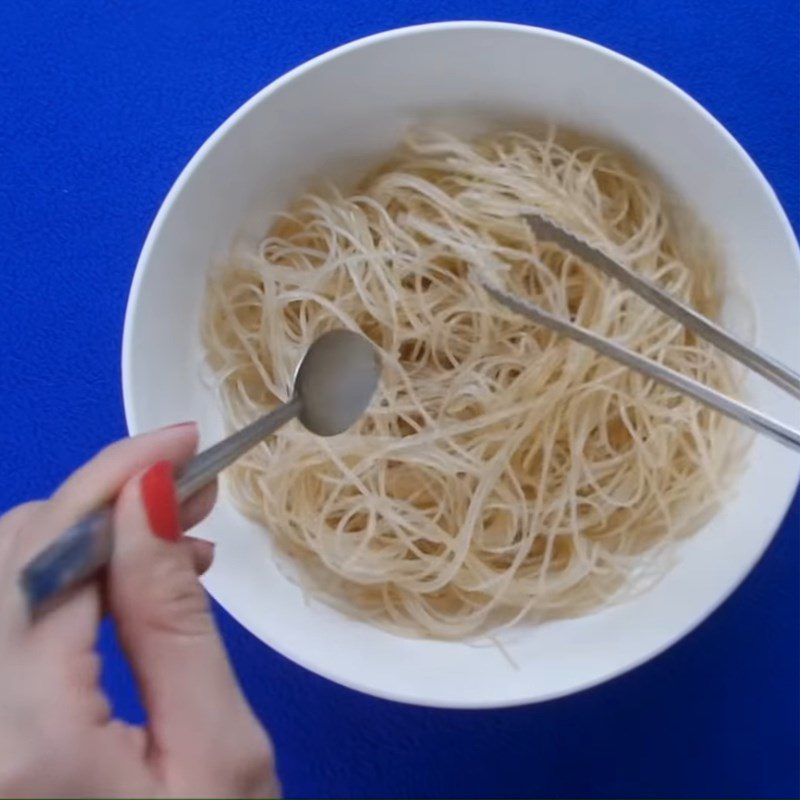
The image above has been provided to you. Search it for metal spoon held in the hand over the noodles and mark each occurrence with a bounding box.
[20,330,380,616]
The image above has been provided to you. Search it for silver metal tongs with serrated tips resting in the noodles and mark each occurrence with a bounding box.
[481,214,800,450]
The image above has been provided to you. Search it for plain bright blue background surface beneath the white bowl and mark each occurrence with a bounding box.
[0,0,800,797]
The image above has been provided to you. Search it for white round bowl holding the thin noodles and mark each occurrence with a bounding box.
[122,22,800,707]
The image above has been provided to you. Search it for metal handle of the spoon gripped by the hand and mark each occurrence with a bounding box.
[20,398,301,618]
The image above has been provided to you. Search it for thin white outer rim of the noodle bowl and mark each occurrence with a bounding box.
[121,19,800,710]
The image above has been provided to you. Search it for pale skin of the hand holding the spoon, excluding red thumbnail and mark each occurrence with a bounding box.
[0,425,279,797]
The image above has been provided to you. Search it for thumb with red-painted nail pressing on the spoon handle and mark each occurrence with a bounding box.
[108,444,272,795]
